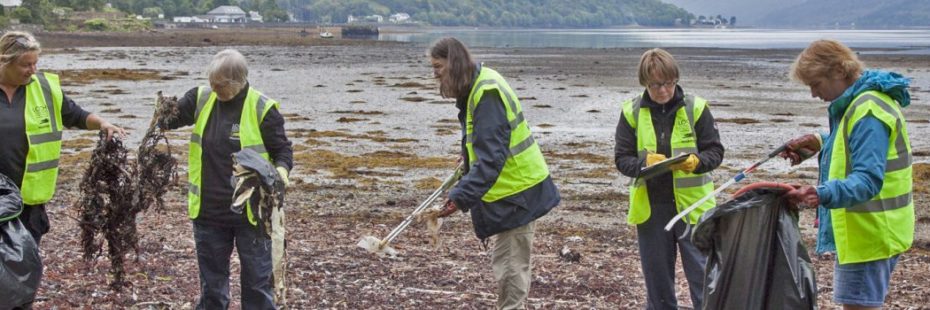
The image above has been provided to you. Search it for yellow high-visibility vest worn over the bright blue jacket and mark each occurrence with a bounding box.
[827,91,914,264]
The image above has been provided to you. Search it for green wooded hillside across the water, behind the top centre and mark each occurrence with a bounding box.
[278,0,693,28]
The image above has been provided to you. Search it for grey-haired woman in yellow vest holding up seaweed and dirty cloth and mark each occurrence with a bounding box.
[160,49,294,309]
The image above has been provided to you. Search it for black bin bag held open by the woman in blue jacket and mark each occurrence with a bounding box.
[692,188,817,310]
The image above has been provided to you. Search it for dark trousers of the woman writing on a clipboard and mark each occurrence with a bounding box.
[636,206,707,310]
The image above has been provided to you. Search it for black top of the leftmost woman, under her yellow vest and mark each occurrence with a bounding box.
[0,77,90,187]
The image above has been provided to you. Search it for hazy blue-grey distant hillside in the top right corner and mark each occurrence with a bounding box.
[760,0,930,28]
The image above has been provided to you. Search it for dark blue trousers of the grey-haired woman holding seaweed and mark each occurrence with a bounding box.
[194,221,275,310]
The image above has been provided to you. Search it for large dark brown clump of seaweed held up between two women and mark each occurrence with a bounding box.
[78,92,178,290]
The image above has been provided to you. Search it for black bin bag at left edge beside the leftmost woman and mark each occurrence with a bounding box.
[0,174,42,309]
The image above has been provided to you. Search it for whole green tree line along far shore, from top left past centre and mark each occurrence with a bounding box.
[9,0,694,27]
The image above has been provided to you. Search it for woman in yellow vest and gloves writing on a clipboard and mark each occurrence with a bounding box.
[614,48,724,309]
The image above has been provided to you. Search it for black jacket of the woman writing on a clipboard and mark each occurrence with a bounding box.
[614,86,724,206]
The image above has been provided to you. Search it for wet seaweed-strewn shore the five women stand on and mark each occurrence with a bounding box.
[27,29,930,309]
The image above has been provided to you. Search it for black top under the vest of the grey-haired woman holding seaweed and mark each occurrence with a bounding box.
[163,84,294,226]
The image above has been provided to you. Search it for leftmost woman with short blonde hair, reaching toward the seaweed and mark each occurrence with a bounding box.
[0,31,126,308]
